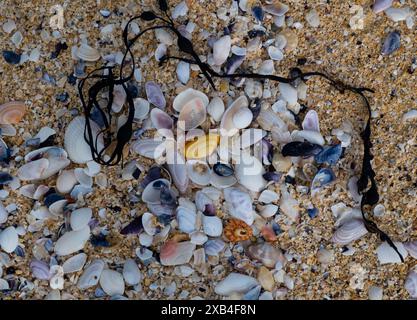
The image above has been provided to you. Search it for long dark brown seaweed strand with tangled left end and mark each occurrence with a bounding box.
[78,0,404,261]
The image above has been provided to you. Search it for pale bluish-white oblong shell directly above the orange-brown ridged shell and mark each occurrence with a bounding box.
[224,187,254,225]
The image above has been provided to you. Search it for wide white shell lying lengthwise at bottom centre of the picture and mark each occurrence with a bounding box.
[214,272,259,296]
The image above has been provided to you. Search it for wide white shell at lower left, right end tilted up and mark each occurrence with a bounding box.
[54,226,90,256]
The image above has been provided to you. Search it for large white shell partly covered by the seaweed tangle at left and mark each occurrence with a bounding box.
[64,116,104,163]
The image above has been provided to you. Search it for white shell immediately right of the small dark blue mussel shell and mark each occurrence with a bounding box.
[235,154,267,192]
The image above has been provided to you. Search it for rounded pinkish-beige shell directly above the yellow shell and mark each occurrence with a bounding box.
[177,97,207,131]
